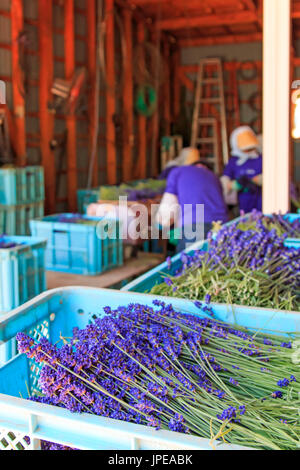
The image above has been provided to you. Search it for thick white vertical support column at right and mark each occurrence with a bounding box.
[263,0,291,213]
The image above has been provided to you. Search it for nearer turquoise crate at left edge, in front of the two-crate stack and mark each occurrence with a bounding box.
[0,236,47,314]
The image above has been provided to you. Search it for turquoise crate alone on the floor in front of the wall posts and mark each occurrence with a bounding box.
[30,214,123,275]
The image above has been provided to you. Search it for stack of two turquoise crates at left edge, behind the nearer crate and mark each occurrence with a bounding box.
[0,166,45,235]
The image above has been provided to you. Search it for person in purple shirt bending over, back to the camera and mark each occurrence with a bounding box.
[158,149,228,251]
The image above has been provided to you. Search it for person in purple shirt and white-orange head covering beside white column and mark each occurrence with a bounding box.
[221,126,263,213]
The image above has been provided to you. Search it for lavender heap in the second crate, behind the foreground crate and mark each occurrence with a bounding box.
[151,225,300,310]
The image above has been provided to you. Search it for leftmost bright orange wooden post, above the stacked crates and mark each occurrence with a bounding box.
[11,0,26,166]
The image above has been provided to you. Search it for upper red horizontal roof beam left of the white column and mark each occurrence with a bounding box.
[157,11,257,31]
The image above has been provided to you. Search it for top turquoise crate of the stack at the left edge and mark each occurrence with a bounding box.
[0,166,45,206]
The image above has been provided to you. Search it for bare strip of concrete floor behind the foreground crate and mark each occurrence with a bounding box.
[47,253,165,289]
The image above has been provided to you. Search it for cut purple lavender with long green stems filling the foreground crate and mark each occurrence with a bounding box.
[17,301,300,450]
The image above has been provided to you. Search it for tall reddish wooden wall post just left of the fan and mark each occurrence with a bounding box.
[38,0,56,214]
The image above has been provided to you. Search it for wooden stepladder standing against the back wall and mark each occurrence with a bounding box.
[191,58,229,173]
